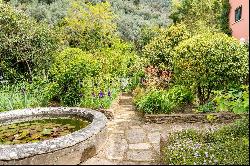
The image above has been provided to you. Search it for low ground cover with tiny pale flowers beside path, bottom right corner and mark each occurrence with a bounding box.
[163,119,249,165]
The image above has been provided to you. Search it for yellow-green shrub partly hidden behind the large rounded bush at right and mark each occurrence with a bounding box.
[143,24,189,70]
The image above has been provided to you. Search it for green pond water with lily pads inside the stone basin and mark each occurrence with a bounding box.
[0,117,89,145]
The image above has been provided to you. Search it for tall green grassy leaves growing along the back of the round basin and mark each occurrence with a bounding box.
[0,81,119,112]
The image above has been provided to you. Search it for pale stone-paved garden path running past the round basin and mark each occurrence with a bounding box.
[81,95,225,165]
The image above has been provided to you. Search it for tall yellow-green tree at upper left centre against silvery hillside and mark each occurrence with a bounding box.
[60,0,116,52]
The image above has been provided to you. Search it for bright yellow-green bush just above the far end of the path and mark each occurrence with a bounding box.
[93,40,143,91]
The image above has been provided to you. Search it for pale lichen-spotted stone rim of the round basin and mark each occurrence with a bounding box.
[0,107,107,161]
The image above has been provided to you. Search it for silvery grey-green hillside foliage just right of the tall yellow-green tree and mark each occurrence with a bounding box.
[110,0,171,42]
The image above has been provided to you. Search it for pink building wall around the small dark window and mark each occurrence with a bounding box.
[229,0,249,42]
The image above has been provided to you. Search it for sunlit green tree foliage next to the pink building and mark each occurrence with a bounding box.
[170,0,231,35]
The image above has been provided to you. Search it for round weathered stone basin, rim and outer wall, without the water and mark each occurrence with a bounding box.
[0,107,107,165]
